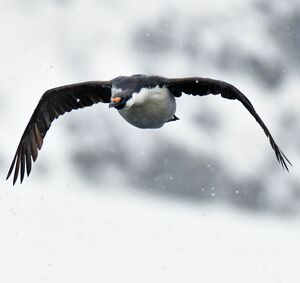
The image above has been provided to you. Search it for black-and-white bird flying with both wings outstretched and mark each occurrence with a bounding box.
[6,74,292,185]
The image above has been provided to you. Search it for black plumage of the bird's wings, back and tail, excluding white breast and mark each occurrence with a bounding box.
[7,75,291,184]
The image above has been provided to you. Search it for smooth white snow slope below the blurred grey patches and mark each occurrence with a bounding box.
[0,187,300,283]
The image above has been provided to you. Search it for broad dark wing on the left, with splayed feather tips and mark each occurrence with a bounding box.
[6,81,111,184]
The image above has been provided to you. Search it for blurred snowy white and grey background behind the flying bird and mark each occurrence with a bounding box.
[0,0,300,282]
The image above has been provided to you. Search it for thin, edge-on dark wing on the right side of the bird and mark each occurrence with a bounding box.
[166,77,292,171]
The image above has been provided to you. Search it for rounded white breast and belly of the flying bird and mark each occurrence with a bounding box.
[119,86,176,129]
